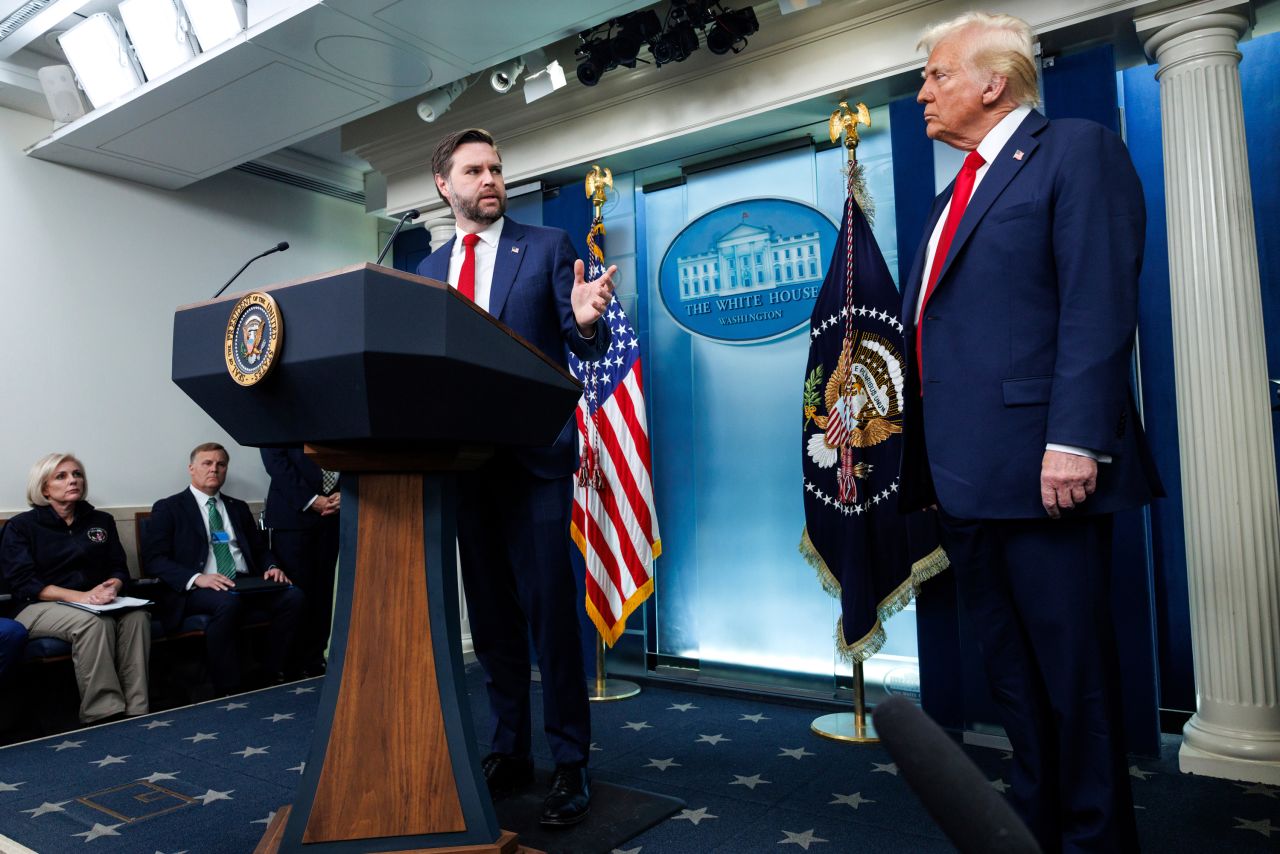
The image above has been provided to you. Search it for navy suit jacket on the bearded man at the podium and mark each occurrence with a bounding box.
[417,216,609,478]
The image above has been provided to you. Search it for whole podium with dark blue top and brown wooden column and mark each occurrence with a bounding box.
[173,264,581,854]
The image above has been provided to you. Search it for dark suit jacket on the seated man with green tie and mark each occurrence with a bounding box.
[142,489,279,593]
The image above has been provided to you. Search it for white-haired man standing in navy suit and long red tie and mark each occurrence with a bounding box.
[902,13,1161,851]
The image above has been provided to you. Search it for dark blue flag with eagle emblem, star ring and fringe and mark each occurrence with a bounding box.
[800,182,947,662]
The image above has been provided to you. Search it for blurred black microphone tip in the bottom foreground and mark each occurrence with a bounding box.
[873,697,1041,854]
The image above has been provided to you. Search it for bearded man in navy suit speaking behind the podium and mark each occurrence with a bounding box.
[417,128,617,827]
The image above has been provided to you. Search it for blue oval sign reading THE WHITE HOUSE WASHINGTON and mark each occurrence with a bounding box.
[659,198,836,342]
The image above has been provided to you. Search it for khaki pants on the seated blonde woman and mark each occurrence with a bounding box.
[17,602,151,723]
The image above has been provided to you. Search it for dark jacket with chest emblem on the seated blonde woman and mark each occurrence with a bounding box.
[0,501,129,602]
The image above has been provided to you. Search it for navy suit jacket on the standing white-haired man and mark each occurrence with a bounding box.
[901,111,1162,519]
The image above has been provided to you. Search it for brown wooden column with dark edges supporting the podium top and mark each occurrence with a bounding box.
[259,447,522,854]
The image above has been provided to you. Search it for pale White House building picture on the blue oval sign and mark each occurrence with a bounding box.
[676,223,823,300]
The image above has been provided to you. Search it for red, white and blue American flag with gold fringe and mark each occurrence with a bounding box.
[568,218,662,647]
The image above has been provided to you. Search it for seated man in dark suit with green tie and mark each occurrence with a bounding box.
[142,442,305,694]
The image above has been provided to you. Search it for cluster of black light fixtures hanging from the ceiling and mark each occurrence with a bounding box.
[575,0,760,86]
